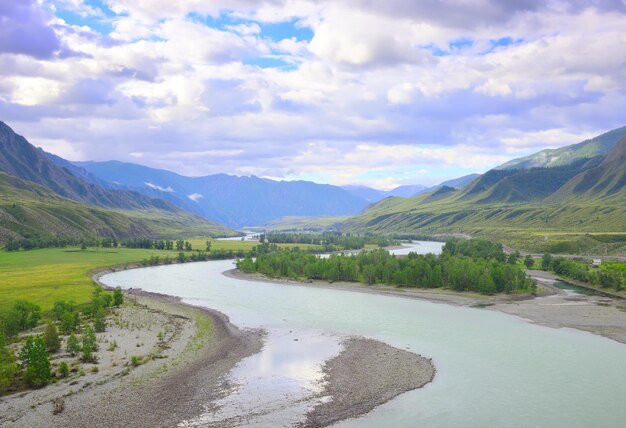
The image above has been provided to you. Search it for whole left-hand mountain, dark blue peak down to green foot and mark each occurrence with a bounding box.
[0,122,237,242]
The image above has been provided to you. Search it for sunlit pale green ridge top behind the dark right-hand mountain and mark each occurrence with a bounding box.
[495,126,626,170]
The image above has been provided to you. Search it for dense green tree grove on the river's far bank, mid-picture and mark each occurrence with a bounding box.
[237,240,536,294]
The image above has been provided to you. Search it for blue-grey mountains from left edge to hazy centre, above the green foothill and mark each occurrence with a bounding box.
[0,122,474,236]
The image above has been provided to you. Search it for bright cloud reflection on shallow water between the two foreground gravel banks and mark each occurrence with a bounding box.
[179,326,341,427]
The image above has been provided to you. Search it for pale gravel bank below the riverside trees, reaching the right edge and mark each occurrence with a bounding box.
[224,269,626,343]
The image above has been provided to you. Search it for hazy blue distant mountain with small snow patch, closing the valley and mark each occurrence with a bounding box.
[76,161,368,228]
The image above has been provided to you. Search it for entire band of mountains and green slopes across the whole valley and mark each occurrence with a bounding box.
[0,118,626,251]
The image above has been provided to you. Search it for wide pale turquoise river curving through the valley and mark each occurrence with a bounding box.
[101,243,626,428]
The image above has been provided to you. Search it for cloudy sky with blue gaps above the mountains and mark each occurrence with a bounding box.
[0,0,626,189]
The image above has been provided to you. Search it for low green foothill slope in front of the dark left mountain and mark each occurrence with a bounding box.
[0,172,233,243]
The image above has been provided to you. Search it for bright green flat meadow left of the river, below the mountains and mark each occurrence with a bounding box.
[0,238,322,311]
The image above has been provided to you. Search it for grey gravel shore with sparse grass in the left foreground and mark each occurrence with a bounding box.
[0,290,262,427]
